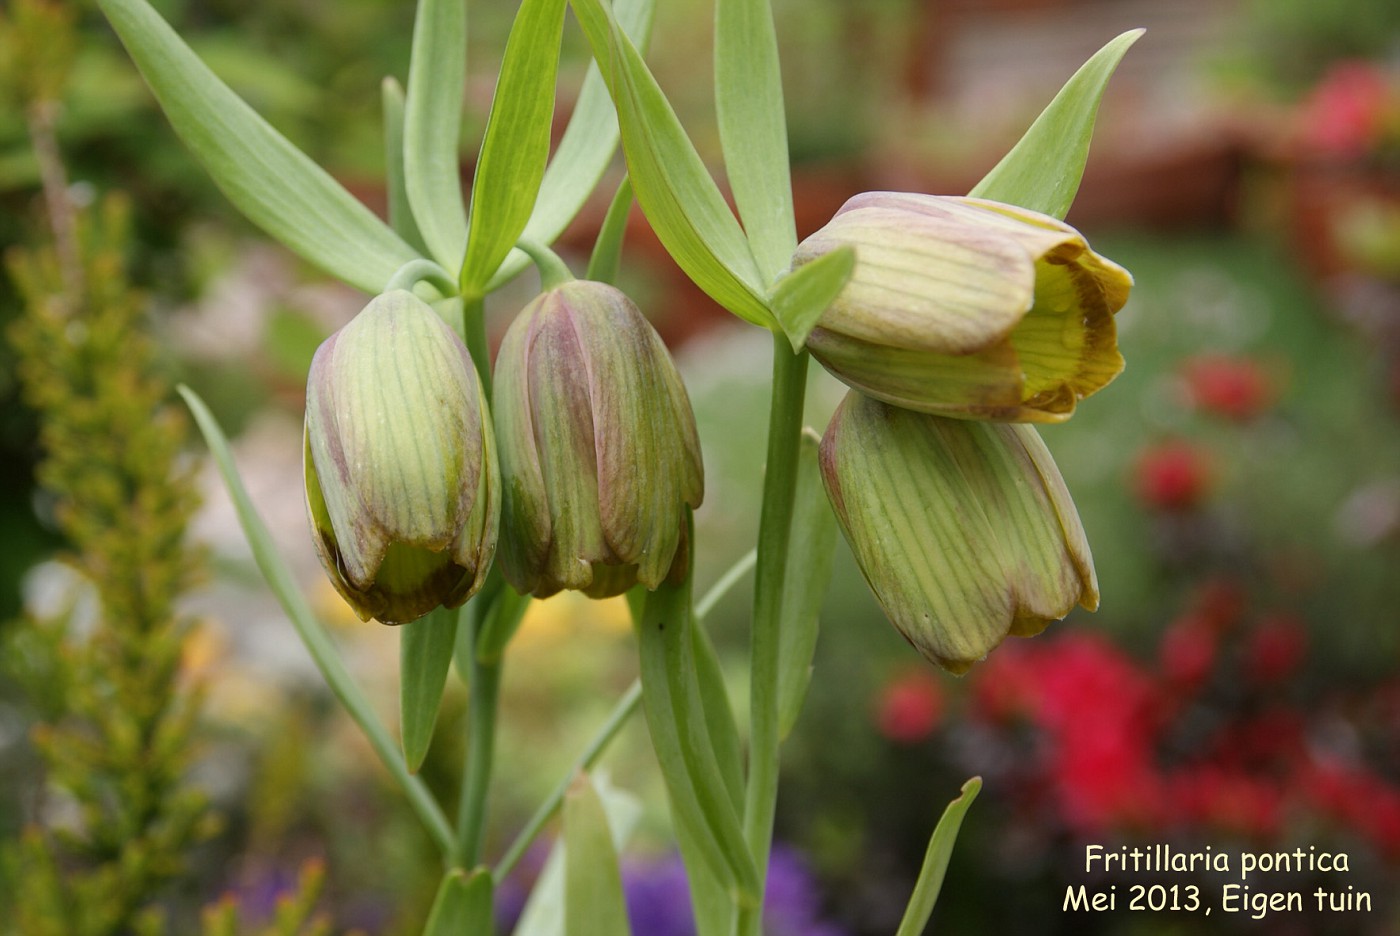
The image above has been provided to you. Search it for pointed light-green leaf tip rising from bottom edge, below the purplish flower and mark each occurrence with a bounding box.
[564,774,631,936]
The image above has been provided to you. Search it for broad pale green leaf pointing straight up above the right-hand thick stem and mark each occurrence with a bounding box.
[714,0,797,283]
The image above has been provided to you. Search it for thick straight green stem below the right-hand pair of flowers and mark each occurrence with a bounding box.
[739,332,808,936]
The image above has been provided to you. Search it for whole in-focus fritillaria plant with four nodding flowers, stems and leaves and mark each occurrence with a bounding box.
[90,0,1137,936]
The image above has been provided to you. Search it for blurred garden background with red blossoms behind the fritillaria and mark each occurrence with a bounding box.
[0,0,1400,936]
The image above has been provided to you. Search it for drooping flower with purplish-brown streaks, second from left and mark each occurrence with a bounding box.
[496,281,704,597]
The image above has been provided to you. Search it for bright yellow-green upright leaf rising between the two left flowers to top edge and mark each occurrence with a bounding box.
[462,0,566,295]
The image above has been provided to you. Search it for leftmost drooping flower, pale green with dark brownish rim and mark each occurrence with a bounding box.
[305,290,500,624]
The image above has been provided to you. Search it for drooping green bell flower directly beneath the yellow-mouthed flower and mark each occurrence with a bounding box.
[820,393,1099,673]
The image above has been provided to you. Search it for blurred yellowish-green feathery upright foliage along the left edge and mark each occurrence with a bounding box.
[0,186,211,936]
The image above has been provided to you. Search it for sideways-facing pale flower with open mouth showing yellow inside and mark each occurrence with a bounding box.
[792,192,1133,423]
